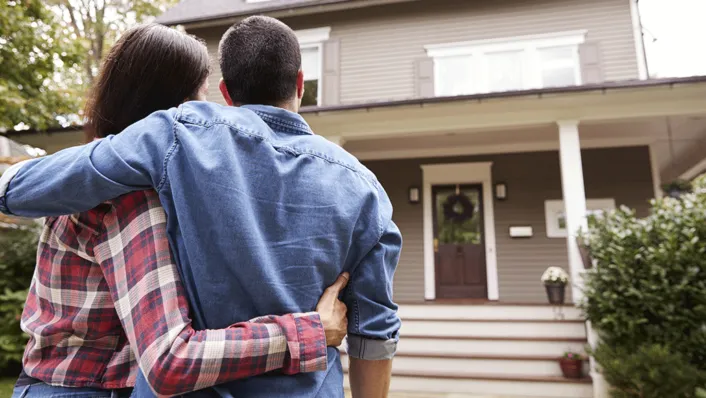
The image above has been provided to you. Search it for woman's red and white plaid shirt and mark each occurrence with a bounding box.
[22,191,326,396]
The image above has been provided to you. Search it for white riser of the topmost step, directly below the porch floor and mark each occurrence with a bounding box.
[398,305,583,320]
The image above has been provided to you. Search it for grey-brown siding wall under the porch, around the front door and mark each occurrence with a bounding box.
[365,147,654,302]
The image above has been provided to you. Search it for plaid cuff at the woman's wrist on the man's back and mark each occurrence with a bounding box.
[282,312,328,374]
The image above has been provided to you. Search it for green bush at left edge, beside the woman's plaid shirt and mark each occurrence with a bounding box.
[0,229,37,376]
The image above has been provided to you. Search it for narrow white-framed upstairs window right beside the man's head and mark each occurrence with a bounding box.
[295,27,331,106]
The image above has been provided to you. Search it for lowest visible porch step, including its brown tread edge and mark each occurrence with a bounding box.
[344,371,593,398]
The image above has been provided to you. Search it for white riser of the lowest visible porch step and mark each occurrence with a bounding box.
[344,375,593,398]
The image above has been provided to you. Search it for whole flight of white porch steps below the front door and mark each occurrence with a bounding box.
[343,305,593,398]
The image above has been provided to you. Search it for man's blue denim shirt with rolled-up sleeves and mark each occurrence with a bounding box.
[0,102,402,398]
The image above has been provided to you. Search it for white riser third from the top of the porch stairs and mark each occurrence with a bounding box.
[397,337,586,357]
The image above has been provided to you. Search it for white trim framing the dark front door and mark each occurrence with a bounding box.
[421,162,499,300]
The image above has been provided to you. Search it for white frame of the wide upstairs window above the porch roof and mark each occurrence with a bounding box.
[424,30,587,95]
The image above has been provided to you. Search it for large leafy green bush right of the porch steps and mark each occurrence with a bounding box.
[582,179,706,397]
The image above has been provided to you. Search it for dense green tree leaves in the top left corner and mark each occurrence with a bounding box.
[0,0,81,131]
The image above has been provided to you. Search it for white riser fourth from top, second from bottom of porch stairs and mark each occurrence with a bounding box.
[342,356,562,377]
